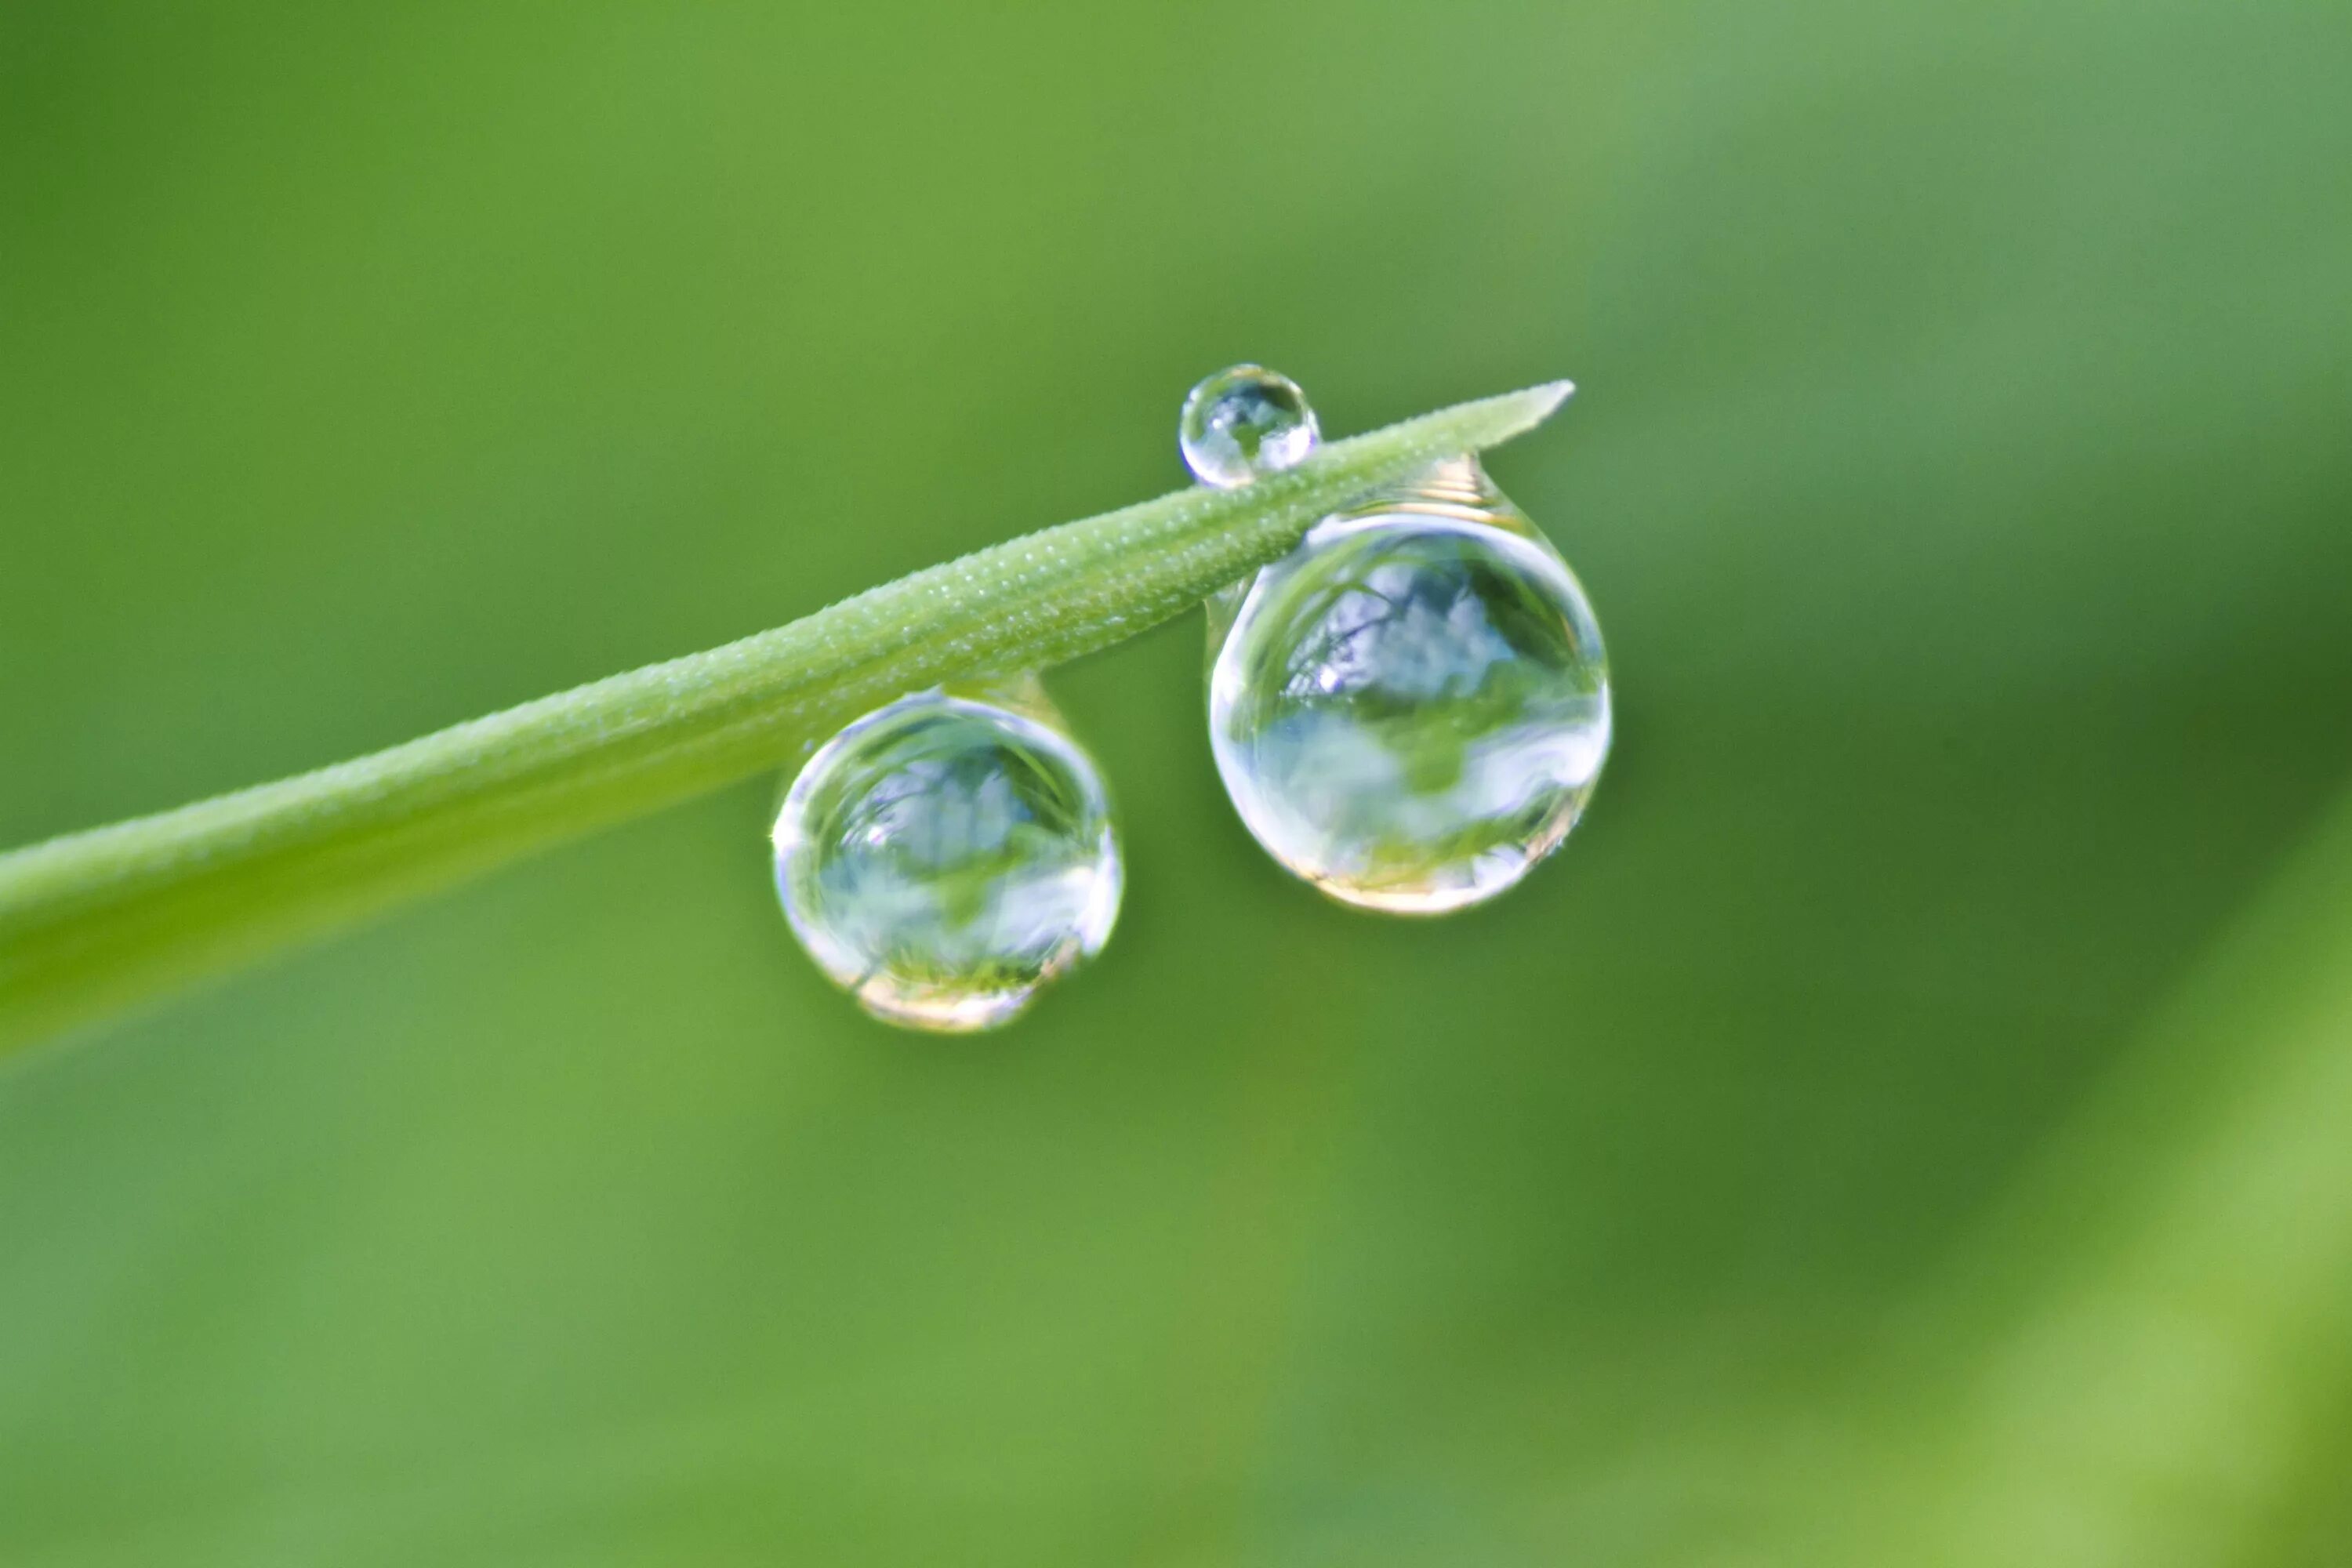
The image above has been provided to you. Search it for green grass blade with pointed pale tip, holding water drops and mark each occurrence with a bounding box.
[0,383,1569,1051]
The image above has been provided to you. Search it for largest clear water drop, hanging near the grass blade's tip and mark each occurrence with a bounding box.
[1209,459,1609,914]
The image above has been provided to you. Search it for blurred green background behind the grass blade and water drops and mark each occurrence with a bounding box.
[0,0,2352,1568]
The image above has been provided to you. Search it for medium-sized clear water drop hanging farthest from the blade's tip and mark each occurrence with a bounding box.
[774,684,1122,1032]
